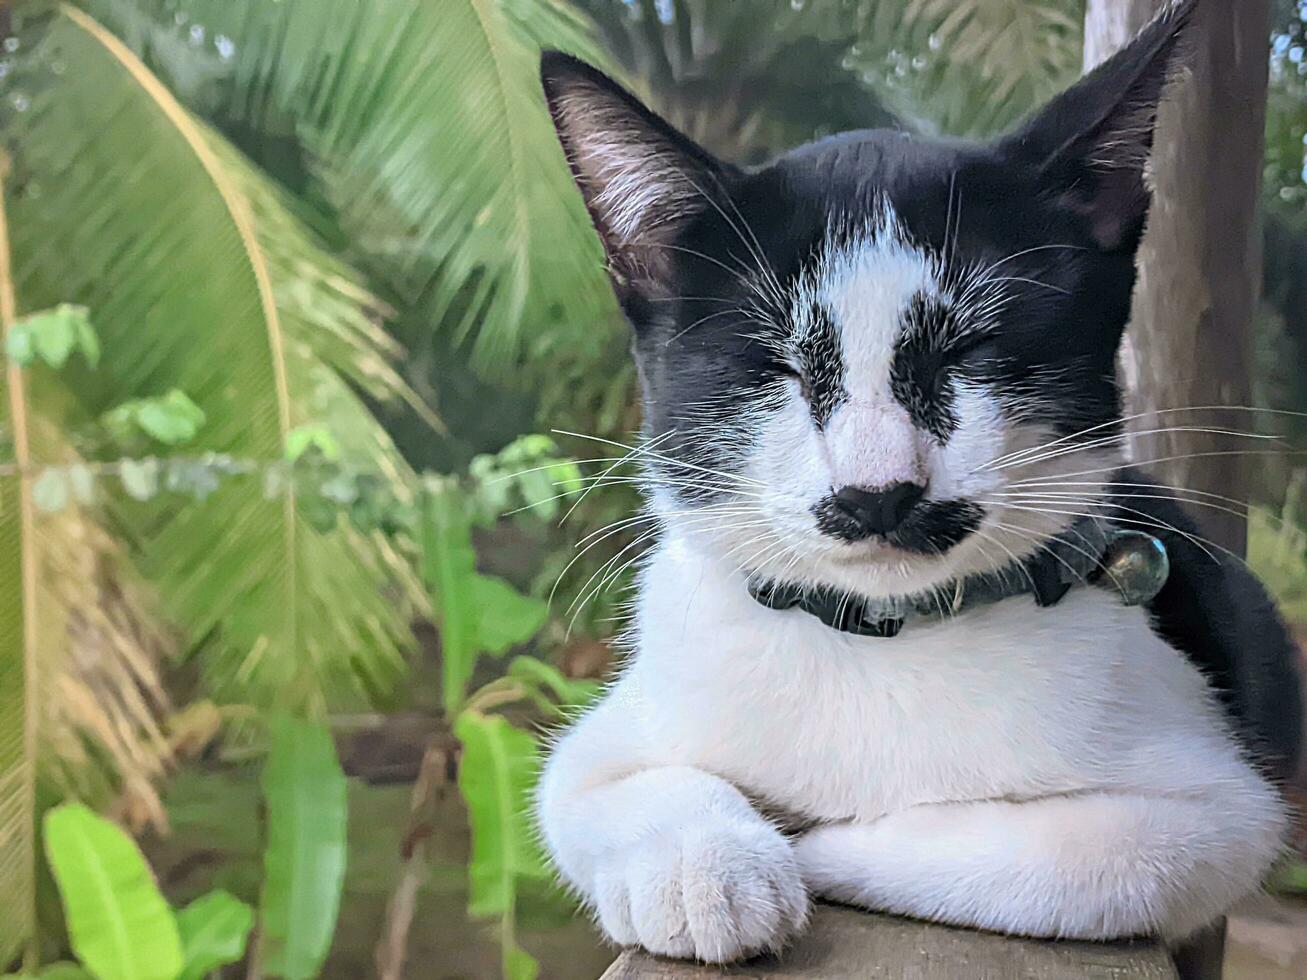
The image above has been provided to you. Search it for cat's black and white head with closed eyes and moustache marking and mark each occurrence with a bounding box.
[542,0,1195,592]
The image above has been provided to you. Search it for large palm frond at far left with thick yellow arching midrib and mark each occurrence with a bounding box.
[3,5,417,712]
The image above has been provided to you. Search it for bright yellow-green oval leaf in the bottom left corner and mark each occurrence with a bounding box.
[43,804,182,980]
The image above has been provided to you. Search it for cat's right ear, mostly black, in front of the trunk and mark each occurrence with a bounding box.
[1002,0,1199,252]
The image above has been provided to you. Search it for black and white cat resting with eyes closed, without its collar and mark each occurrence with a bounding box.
[538,1,1300,962]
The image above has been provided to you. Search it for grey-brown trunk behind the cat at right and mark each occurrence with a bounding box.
[1085,0,1270,555]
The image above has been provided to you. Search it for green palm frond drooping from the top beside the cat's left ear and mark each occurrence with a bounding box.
[93,0,622,372]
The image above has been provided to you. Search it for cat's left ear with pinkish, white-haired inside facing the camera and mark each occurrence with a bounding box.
[540,51,728,291]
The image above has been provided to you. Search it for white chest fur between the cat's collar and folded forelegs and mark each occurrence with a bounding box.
[621,541,1249,821]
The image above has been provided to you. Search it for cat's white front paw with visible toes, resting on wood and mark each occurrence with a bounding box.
[595,821,808,963]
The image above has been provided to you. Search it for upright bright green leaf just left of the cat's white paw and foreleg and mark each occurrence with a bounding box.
[454,711,549,977]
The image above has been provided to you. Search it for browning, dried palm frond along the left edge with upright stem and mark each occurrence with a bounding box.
[0,203,171,966]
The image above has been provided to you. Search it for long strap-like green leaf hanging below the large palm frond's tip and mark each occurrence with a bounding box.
[260,719,346,980]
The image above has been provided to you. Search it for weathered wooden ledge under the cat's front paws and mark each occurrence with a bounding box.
[604,906,1176,980]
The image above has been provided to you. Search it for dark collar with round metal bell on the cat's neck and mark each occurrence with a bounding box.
[749,517,1170,638]
